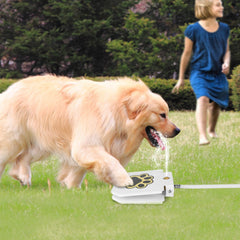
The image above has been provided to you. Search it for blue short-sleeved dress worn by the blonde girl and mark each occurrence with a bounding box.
[185,22,230,108]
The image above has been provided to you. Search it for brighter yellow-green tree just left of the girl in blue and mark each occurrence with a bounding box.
[107,1,183,78]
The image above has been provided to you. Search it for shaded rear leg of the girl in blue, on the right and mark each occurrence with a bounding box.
[208,102,220,138]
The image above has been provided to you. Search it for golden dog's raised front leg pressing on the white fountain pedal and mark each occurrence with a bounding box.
[72,147,133,187]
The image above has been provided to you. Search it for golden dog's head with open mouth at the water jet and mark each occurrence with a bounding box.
[125,82,180,148]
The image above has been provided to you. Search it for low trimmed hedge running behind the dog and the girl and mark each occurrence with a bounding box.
[0,77,237,111]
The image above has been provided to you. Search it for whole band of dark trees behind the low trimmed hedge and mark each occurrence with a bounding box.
[0,0,240,79]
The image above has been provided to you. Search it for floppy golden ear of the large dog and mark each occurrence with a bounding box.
[123,91,148,120]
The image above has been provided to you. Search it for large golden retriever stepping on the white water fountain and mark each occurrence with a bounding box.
[0,75,180,188]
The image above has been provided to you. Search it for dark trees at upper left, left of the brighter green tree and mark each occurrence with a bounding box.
[0,0,136,76]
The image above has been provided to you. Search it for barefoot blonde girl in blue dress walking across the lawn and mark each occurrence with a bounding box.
[172,0,230,145]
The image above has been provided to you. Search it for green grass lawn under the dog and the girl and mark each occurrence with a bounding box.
[0,112,240,240]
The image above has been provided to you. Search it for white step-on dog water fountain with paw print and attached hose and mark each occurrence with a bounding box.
[111,170,240,204]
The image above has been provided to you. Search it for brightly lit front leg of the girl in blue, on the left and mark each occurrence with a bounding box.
[196,96,209,145]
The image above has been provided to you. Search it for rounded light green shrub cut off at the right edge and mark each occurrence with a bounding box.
[231,65,240,111]
